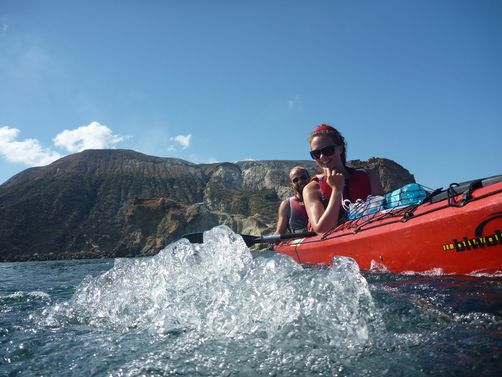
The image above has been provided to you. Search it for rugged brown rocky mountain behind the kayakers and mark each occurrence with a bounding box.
[0,150,414,261]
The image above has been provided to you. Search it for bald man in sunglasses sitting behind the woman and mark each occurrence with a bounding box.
[275,166,310,234]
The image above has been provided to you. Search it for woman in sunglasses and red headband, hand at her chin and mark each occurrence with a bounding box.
[303,124,383,233]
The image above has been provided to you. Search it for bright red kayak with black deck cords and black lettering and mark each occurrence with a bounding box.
[274,176,502,274]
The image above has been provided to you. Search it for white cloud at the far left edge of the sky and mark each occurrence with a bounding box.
[0,126,61,166]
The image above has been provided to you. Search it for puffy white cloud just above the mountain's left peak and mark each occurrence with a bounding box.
[54,122,127,153]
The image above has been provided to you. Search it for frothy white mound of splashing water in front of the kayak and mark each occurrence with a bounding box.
[65,226,377,356]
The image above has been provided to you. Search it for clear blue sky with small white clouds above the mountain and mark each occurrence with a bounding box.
[0,0,502,187]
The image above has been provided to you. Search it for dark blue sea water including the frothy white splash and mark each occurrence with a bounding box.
[0,226,502,376]
